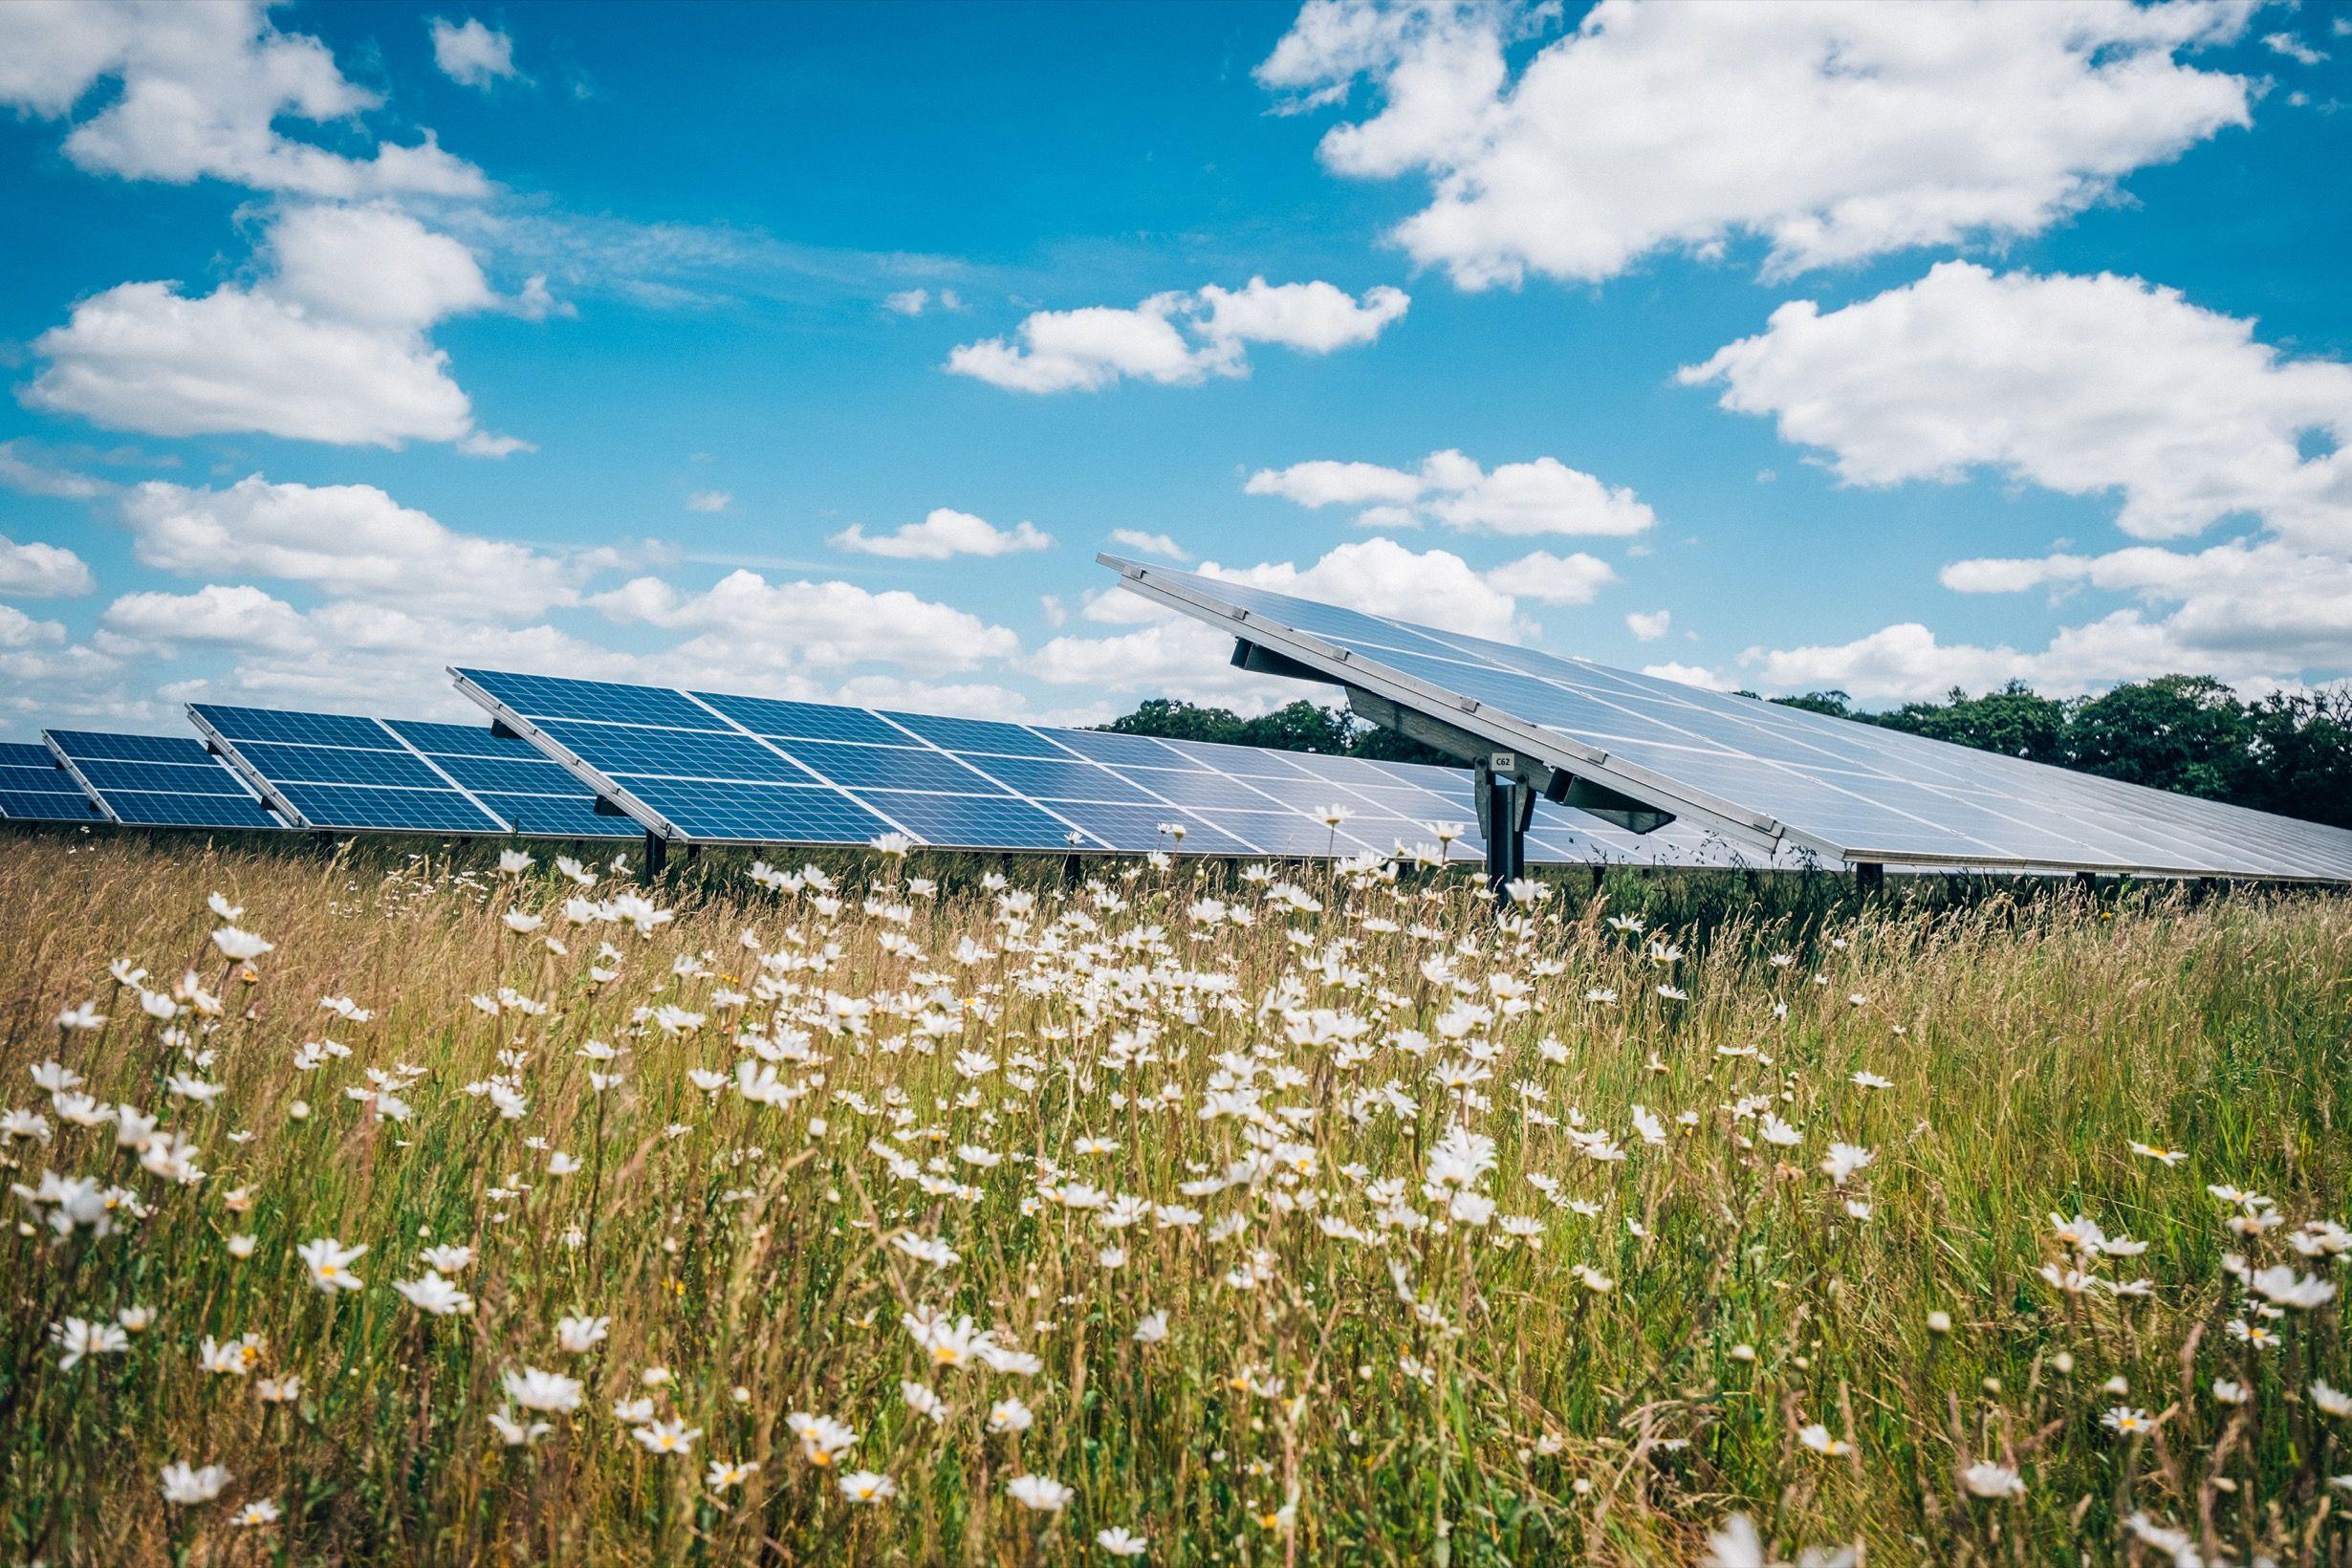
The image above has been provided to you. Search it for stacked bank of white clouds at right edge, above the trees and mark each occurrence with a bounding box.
[1684,261,2352,696]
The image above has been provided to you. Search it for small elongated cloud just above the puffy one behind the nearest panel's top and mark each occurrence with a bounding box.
[1242,451,1658,538]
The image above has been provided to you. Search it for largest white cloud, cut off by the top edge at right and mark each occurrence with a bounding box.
[1258,0,2251,289]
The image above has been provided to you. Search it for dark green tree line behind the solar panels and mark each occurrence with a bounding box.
[1103,675,2352,827]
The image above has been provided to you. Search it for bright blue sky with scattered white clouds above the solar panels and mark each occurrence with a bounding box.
[0,0,2352,736]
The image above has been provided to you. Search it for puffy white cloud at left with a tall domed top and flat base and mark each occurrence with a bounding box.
[27,199,522,456]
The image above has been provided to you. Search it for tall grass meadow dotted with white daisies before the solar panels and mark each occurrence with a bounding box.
[0,837,2352,1563]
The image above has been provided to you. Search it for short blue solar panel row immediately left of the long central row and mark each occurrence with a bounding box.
[188,703,638,839]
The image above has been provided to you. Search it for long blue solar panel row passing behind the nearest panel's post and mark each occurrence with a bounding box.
[451,670,1762,865]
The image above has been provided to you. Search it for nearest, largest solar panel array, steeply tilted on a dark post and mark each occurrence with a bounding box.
[1099,555,2352,882]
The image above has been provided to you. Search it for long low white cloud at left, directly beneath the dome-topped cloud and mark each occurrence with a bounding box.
[120,475,581,621]
